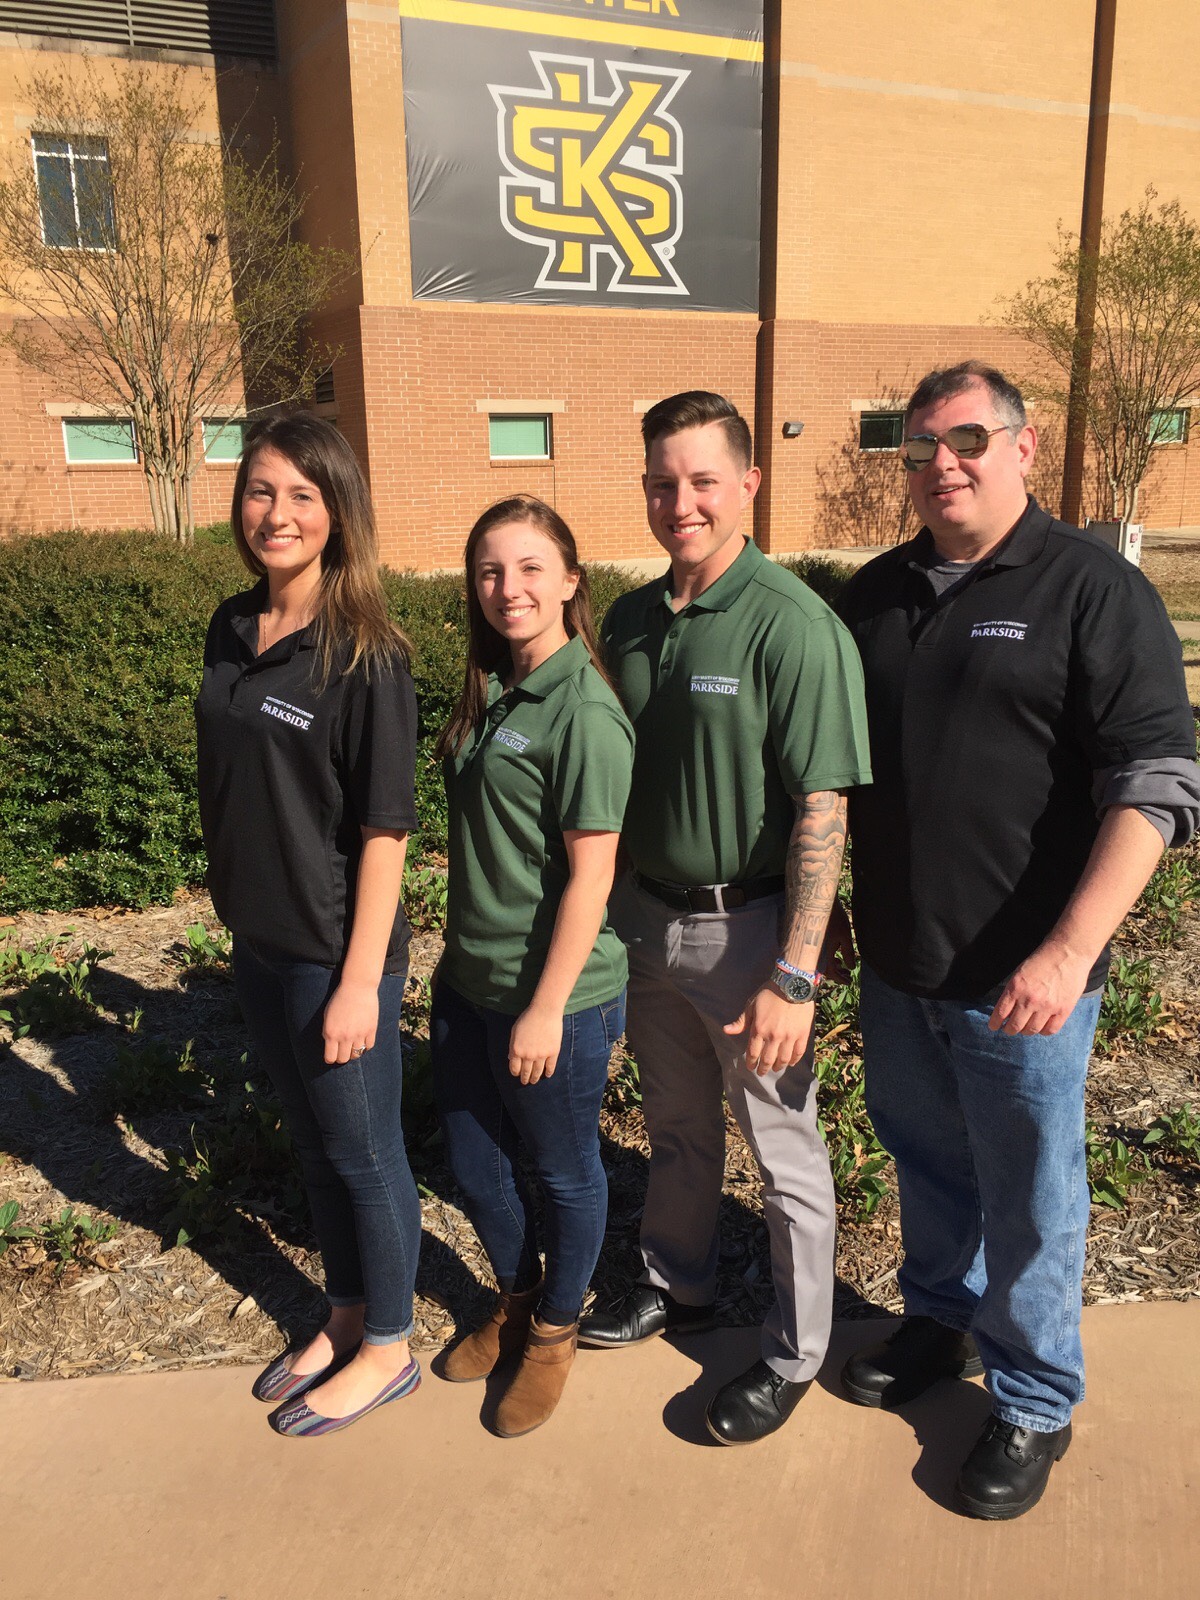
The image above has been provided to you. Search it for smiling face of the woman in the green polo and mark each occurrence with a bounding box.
[472,522,579,672]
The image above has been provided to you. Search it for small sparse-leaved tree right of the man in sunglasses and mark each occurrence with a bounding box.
[1002,189,1200,522]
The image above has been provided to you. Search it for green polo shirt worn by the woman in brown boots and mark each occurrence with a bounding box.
[442,638,634,1016]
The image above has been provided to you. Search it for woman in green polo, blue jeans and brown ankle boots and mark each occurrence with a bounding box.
[430,494,634,1437]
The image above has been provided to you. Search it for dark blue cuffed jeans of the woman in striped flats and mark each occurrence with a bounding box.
[234,939,421,1344]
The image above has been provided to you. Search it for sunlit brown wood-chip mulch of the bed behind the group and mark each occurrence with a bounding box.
[0,870,1200,1378]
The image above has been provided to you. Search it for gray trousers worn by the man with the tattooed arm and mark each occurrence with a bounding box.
[610,877,835,1382]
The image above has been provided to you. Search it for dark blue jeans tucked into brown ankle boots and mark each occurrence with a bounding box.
[429,982,626,1325]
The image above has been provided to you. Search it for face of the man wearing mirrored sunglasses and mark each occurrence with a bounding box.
[904,382,1037,560]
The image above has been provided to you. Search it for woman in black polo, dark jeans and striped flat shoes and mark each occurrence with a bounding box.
[197,414,421,1435]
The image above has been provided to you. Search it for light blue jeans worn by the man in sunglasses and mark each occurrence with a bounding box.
[862,963,1101,1434]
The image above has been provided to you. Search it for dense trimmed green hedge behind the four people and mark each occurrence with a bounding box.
[0,525,864,914]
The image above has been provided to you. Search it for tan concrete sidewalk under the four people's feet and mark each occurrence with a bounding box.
[0,1302,1200,1600]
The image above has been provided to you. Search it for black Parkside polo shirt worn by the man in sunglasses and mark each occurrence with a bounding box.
[838,499,1195,1000]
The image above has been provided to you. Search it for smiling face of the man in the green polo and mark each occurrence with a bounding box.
[642,422,762,586]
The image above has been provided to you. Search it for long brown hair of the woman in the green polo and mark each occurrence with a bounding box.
[434,494,613,760]
